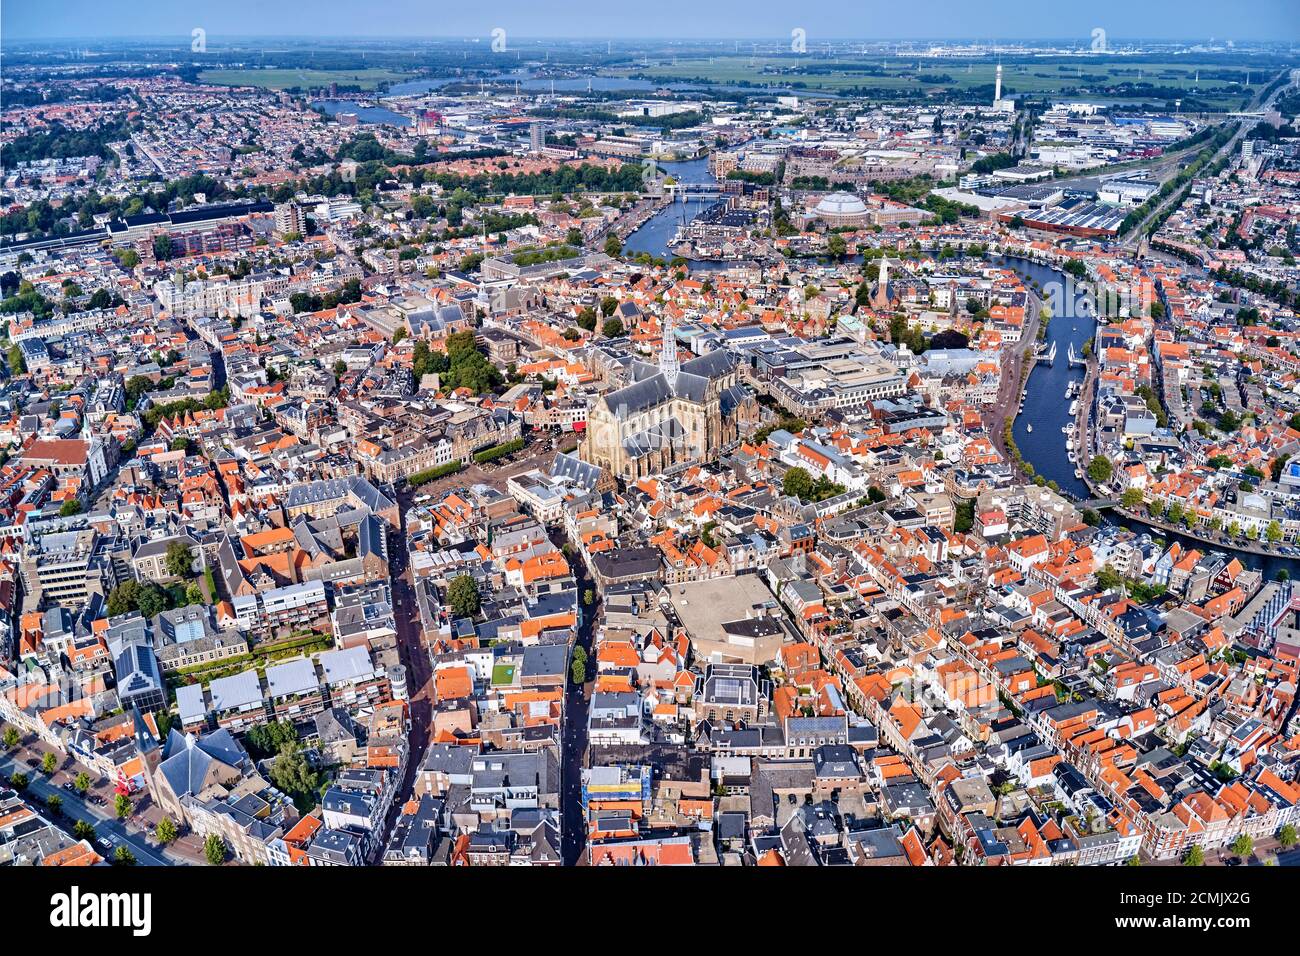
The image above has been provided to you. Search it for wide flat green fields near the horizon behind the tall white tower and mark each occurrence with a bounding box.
[616,56,1281,109]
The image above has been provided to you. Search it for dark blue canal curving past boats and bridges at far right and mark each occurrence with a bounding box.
[998,256,1300,580]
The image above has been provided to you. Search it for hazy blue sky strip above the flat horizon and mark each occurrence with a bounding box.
[0,0,1300,43]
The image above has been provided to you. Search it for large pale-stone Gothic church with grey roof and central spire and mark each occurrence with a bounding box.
[581,323,758,480]
